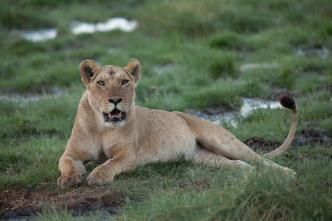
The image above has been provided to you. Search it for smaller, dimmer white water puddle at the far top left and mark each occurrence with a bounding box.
[11,28,58,42]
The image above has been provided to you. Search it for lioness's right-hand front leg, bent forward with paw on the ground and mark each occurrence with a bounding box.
[87,151,136,185]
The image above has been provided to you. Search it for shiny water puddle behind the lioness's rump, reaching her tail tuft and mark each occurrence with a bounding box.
[185,98,282,127]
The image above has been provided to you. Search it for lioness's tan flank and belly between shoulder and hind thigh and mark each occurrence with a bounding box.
[137,108,197,165]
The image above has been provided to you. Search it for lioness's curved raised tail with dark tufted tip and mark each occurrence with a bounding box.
[263,94,297,158]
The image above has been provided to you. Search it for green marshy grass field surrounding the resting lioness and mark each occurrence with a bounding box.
[0,0,332,220]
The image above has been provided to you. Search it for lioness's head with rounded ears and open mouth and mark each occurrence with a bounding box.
[80,58,141,128]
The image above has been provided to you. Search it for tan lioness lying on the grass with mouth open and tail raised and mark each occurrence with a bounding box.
[58,59,297,188]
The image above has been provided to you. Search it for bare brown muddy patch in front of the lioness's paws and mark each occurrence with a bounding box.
[0,189,125,219]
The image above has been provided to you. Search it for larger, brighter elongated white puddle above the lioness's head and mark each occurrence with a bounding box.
[70,18,137,34]
